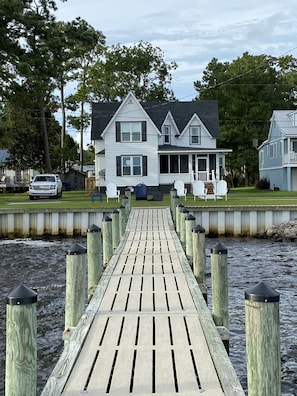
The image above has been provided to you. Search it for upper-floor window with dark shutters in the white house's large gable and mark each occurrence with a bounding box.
[116,121,146,143]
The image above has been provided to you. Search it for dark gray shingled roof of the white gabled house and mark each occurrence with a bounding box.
[91,100,220,140]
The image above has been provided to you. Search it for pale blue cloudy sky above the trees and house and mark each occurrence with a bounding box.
[56,0,297,145]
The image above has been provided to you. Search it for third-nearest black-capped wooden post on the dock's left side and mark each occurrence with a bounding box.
[87,224,103,301]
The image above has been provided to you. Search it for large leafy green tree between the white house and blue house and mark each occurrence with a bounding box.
[194,52,290,185]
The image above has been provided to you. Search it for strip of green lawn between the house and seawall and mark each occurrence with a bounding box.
[0,187,297,210]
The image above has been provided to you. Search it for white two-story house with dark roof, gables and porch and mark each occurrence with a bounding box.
[91,93,231,192]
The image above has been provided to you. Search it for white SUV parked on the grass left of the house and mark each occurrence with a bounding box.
[29,173,62,199]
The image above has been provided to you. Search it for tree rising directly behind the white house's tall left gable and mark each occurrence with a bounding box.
[86,41,177,101]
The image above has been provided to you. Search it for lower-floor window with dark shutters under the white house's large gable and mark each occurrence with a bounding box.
[116,155,147,176]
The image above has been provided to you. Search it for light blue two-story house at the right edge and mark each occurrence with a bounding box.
[258,110,297,191]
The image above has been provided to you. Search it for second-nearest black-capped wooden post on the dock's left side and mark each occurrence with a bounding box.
[63,243,87,344]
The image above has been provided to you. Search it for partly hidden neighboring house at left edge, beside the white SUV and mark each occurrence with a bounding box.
[0,149,36,192]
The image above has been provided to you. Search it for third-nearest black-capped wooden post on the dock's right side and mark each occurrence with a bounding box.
[192,224,207,301]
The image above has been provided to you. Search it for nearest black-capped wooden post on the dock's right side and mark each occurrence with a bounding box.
[245,282,281,396]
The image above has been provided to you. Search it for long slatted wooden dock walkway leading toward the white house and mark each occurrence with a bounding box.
[42,208,244,396]
